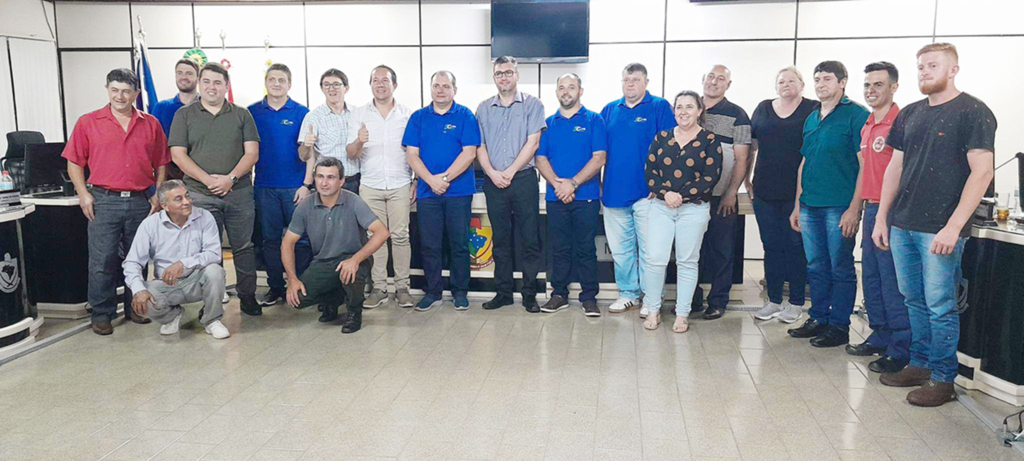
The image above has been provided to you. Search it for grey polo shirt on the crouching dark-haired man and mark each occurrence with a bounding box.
[288,188,378,261]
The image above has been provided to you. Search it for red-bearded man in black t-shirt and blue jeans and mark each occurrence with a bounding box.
[871,43,996,407]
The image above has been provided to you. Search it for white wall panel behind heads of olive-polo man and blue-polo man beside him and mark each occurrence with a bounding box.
[198,48,306,107]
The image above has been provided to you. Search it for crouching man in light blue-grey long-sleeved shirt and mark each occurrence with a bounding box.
[123,179,231,339]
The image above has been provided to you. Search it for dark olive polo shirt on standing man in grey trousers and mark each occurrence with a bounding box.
[167,100,259,196]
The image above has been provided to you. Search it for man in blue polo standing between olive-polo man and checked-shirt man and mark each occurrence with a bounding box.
[249,62,314,310]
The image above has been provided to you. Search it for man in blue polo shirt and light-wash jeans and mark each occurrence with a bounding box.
[601,62,676,318]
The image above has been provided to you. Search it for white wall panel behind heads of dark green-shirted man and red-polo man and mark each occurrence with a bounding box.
[797,38,931,108]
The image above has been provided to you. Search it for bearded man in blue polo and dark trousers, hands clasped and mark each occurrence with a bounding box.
[537,74,608,317]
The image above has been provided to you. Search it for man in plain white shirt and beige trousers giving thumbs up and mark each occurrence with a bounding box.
[346,65,416,309]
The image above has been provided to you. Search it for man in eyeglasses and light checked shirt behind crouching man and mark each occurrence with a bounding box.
[299,69,360,194]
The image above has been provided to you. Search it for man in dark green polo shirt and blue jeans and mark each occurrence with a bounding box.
[790,60,870,347]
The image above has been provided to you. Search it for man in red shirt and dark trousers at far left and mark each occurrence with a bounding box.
[62,69,171,335]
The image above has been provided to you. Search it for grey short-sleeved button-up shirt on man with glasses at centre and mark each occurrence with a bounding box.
[476,91,548,171]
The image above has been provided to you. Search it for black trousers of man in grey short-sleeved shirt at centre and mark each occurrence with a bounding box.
[483,168,543,296]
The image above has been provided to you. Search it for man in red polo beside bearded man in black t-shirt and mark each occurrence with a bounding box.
[846,61,910,373]
